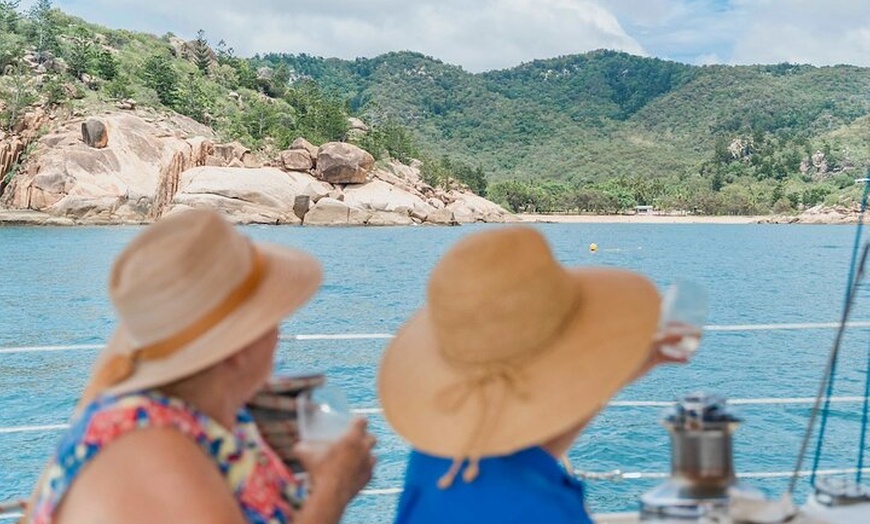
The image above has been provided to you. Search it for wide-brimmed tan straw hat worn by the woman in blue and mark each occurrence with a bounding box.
[378,227,659,487]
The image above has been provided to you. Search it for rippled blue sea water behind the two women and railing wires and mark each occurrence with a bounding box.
[0,224,870,523]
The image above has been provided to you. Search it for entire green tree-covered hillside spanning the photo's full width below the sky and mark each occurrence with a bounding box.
[0,0,870,214]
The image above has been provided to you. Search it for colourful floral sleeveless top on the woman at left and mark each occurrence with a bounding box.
[31,391,301,524]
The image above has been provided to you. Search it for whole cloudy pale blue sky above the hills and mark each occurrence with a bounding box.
[15,0,870,73]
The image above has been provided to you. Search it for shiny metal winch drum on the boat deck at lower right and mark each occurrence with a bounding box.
[641,393,758,521]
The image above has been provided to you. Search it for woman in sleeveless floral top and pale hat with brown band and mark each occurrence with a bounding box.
[28,211,374,524]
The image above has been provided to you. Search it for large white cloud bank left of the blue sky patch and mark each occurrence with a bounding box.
[34,0,646,71]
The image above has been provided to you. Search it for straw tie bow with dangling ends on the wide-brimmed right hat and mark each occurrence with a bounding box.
[438,359,529,489]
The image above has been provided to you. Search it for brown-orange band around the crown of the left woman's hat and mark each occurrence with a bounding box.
[79,242,266,407]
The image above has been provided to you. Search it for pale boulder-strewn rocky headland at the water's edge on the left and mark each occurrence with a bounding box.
[0,110,517,226]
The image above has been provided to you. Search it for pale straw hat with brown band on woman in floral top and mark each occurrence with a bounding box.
[85,210,321,401]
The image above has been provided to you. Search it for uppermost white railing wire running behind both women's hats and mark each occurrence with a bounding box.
[0,320,870,355]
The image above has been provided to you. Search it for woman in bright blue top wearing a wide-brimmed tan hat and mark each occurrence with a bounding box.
[378,227,692,524]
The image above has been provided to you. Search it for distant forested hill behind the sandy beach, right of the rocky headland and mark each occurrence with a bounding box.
[263,51,870,213]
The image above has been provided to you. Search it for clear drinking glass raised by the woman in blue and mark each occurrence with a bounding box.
[659,280,709,360]
